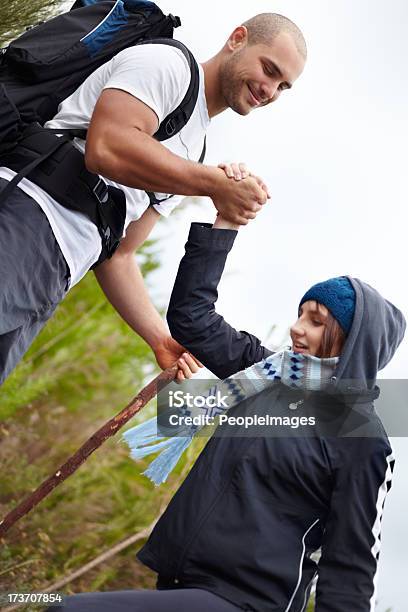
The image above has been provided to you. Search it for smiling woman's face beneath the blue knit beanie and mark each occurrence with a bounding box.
[290,300,341,357]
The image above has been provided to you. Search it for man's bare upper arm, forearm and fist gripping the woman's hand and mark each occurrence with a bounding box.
[85,89,266,225]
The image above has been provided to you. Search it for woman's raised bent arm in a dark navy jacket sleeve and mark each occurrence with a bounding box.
[167,220,271,378]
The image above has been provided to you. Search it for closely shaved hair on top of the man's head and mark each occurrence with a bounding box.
[242,13,307,59]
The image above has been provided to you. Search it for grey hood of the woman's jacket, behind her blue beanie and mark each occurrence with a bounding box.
[333,277,406,389]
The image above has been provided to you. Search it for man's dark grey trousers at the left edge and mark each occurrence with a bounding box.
[0,178,69,385]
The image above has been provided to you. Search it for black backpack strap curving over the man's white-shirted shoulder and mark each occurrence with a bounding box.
[139,38,200,141]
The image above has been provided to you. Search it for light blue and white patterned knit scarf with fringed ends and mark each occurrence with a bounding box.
[122,350,339,485]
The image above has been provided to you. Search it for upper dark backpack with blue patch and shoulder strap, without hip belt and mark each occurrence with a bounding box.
[0,0,198,156]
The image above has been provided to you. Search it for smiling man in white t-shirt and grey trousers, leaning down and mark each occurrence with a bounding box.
[0,13,306,384]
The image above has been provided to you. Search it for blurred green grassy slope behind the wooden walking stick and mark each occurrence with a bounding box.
[0,243,198,592]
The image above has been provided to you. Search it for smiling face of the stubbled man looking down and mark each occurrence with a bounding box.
[221,32,305,115]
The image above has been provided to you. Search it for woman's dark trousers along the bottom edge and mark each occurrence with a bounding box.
[48,589,241,612]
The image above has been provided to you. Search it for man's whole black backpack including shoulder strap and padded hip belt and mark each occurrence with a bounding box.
[0,0,205,261]
